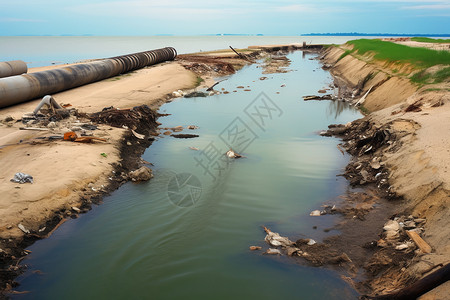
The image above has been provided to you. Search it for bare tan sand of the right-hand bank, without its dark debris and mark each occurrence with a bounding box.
[323,47,450,299]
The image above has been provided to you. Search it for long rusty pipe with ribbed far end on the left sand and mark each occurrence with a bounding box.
[0,47,177,108]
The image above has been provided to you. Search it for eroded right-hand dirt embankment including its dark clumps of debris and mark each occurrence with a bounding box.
[322,47,450,299]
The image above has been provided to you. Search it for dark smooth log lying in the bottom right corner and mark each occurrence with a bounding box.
[361,263,450,300]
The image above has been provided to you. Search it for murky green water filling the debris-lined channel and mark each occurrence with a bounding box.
[14,52,360,299]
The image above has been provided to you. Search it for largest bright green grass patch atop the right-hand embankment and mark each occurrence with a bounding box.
[347,39,450,68]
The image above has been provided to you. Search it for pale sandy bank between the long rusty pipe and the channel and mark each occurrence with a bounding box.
[0,62,196,241]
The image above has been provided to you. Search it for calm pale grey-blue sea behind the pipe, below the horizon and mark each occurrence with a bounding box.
[0,36,368,68]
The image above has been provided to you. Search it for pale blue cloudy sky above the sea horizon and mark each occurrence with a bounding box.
[0,0,450,36]
